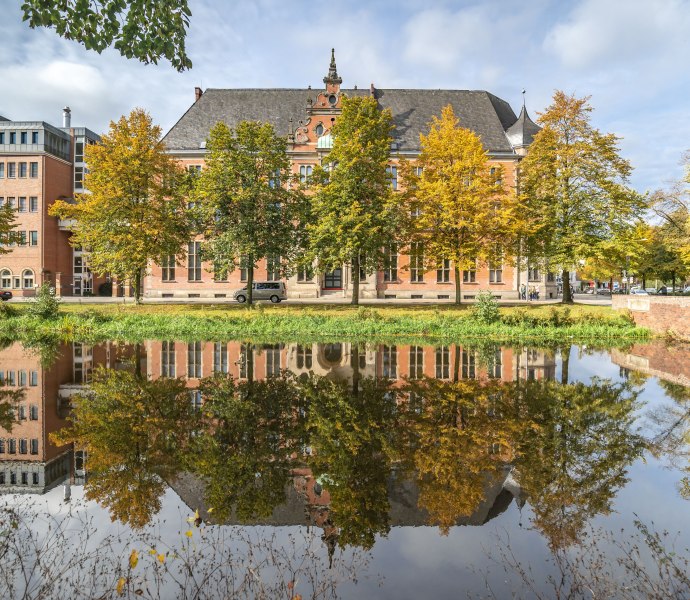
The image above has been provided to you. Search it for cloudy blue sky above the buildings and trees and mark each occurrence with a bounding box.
[0,0,690,192]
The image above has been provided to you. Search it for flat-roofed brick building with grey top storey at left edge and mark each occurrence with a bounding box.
[0,108,101,296]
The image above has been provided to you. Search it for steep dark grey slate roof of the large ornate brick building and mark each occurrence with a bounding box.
[163,89,516,153]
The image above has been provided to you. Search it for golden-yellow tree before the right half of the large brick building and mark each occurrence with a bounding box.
[405,105,522,304]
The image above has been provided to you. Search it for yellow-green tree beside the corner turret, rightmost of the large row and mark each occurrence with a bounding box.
[520,91,647,302]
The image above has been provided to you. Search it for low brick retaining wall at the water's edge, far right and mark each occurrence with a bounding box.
[612,295,690,340]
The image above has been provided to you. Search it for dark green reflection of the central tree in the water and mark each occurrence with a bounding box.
[304,352,398,548]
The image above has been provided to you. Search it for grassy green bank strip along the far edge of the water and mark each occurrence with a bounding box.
[0,304,650,343]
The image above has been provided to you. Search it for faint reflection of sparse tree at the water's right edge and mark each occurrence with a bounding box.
[647,380,690,500]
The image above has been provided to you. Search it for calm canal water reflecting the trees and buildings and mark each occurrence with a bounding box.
[0,341,690,599]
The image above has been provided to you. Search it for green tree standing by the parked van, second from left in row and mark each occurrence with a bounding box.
[195,121,307,304]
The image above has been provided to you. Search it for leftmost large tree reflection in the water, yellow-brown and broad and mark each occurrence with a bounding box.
[51,369,197,527]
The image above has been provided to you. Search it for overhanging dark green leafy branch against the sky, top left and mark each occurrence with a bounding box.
[21,0,192,71]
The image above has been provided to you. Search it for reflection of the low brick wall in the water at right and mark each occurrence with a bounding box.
[611,340,690,386]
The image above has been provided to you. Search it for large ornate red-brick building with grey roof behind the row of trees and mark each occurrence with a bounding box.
[144,54,556,300]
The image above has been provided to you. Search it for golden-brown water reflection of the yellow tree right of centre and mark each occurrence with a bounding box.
[405,378,524,533]
